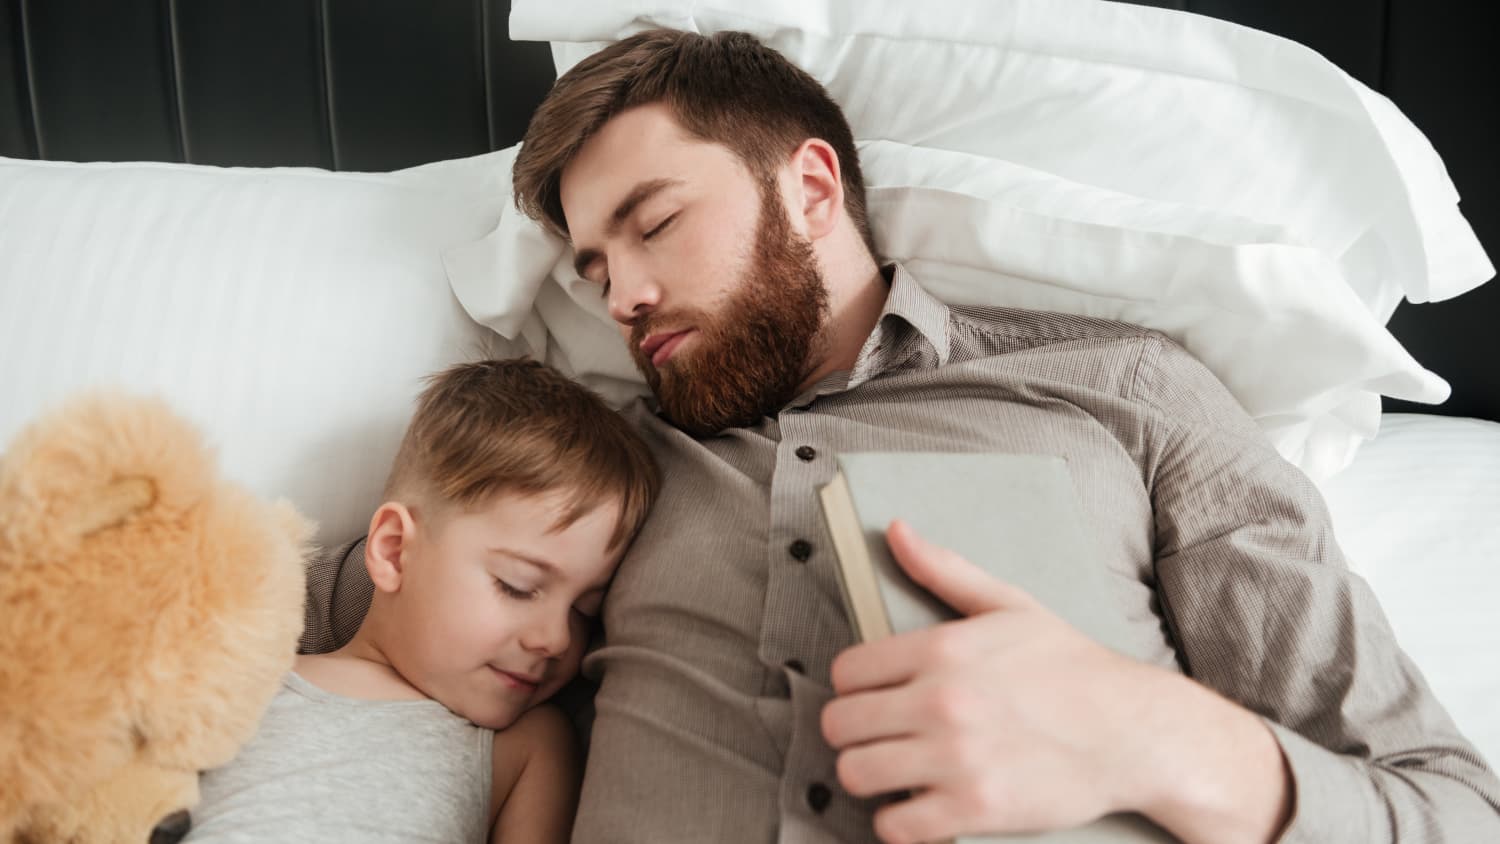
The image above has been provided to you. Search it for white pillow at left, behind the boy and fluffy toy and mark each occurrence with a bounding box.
[0,154,510,543]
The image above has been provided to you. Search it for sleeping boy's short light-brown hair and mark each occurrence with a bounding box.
[386,360,660,547]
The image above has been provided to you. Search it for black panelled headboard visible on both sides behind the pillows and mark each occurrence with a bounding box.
[0,0,1500,420]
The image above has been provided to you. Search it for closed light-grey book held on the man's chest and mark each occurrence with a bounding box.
[819,451,1175,844]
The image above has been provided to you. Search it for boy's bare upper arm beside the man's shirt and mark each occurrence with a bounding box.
[489,705,582,844]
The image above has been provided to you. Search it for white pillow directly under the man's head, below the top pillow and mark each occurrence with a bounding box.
[449,141,1448,477]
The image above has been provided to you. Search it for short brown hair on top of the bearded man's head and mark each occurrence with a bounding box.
[512,28,875,255]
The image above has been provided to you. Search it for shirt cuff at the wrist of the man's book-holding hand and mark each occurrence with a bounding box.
[1266,721,1391,844]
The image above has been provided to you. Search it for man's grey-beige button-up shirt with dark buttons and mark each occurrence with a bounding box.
[298,267,1500,844]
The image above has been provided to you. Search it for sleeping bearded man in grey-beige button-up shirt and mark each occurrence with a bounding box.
[314,30,1500,843]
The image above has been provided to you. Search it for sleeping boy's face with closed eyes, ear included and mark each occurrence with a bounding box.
[386,495,623,729]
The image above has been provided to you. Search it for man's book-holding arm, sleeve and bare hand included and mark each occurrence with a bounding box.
[824,340,1500,843]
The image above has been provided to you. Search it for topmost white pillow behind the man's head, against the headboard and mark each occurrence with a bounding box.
[510,0,1494,313]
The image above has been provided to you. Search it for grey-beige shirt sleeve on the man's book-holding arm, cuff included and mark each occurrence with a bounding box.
[1136,337,1500,844]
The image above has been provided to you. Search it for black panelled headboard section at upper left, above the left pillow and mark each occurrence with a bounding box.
[0,0,554,171]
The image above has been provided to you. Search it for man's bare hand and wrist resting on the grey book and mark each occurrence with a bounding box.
[822,522,1287,844]
